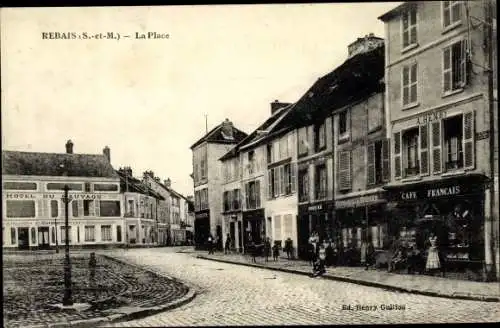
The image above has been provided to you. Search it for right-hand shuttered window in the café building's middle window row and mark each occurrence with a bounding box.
[443,40,467,93]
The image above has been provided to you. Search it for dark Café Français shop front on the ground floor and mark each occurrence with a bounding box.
[385,174,487,280]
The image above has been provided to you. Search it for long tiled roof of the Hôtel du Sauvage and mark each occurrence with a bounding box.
[2,150,118,178]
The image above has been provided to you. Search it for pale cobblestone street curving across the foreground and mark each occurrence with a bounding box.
[102,248,500,327]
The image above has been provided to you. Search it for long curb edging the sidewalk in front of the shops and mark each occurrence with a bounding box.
[196,255,500,302]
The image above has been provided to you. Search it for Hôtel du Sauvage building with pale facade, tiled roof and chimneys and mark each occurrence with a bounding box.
[2,141,125,249]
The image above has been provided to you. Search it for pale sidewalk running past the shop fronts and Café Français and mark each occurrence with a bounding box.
[193,251,500,302]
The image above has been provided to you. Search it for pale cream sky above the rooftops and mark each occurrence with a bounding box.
[1,2,399,195]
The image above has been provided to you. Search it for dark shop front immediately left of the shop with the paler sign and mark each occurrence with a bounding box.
[297,201,335,259]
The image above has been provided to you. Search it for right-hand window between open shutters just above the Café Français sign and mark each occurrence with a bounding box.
[443,115,464,171]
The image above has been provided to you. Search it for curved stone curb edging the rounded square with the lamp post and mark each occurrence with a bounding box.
[18,254,197,328]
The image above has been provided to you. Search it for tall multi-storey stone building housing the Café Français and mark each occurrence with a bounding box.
[380,0,499,278]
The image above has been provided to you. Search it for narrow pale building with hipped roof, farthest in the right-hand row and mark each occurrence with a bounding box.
[191,119,247,248]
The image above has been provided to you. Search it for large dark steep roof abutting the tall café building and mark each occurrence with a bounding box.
[273,46,385,131]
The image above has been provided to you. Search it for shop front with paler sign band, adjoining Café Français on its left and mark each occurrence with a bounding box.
[334,190,389,263]
